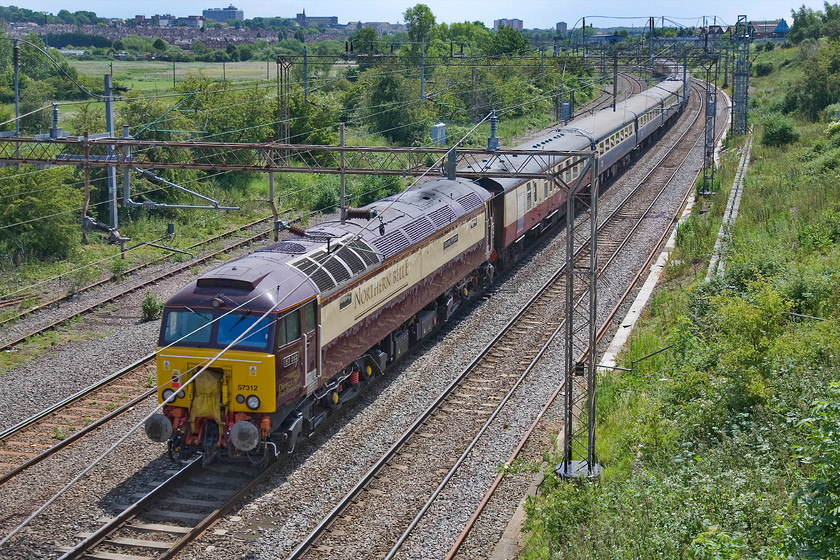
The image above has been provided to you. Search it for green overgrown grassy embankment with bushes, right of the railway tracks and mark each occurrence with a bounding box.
[521,28,840,560]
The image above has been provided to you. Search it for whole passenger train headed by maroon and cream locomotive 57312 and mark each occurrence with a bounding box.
[146,79,687,461]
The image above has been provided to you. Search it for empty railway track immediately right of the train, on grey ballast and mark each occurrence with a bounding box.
[288,77,702,560]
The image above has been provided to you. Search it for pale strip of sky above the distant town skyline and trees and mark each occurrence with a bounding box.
[13,0,823,29]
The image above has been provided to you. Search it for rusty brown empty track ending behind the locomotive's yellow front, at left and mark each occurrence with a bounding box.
[0,354,157,485]
